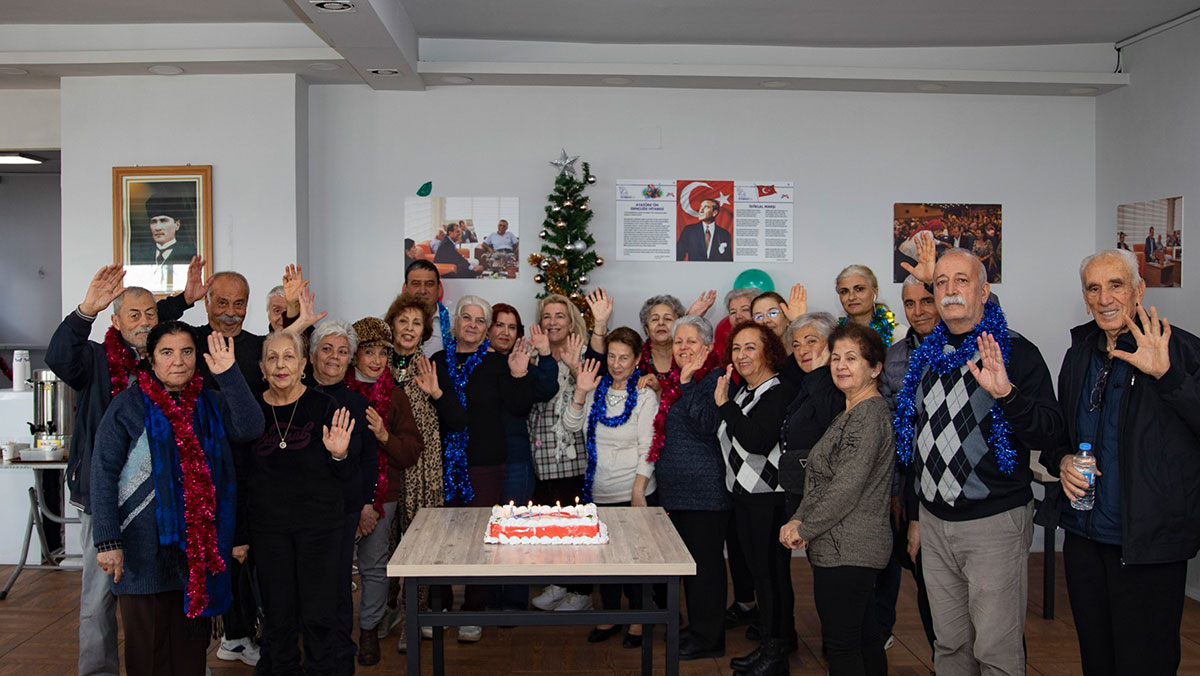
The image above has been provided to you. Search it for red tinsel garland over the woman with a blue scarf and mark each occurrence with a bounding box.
[137,369,226,617]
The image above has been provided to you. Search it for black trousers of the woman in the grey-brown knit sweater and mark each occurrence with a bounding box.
[812,566,888,676]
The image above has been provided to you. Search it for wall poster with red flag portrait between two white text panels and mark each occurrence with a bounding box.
[617,179,794,263]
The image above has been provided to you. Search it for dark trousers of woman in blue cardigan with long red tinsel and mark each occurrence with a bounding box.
[116,592,209,676]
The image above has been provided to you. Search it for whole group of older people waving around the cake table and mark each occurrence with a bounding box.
[48,231,1200,675]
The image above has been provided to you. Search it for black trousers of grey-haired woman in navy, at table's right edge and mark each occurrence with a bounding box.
[670,509,730,650]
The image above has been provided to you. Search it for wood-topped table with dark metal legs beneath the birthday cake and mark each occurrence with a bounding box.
[388,507,696,676]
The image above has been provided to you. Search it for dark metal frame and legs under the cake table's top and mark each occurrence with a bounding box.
[404,575,682,676]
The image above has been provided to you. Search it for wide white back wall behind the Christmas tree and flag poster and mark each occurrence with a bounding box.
[308,86,1096,372]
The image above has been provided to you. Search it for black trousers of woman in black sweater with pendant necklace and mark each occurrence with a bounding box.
[251,525,344,676]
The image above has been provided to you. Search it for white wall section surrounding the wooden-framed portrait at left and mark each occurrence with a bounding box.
[62,74,307,339]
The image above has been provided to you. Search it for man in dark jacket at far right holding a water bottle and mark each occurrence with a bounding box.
[1039,250,1200,675]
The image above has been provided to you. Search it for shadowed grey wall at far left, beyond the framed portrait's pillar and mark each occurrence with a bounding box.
[0,174,62,358]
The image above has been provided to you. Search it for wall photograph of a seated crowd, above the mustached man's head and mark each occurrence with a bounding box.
[892,202,1003,285]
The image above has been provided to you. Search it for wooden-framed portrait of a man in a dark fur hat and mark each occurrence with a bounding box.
[113,164,212,295]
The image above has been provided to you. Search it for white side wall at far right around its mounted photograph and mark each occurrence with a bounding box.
[1096,20,1200,336]
